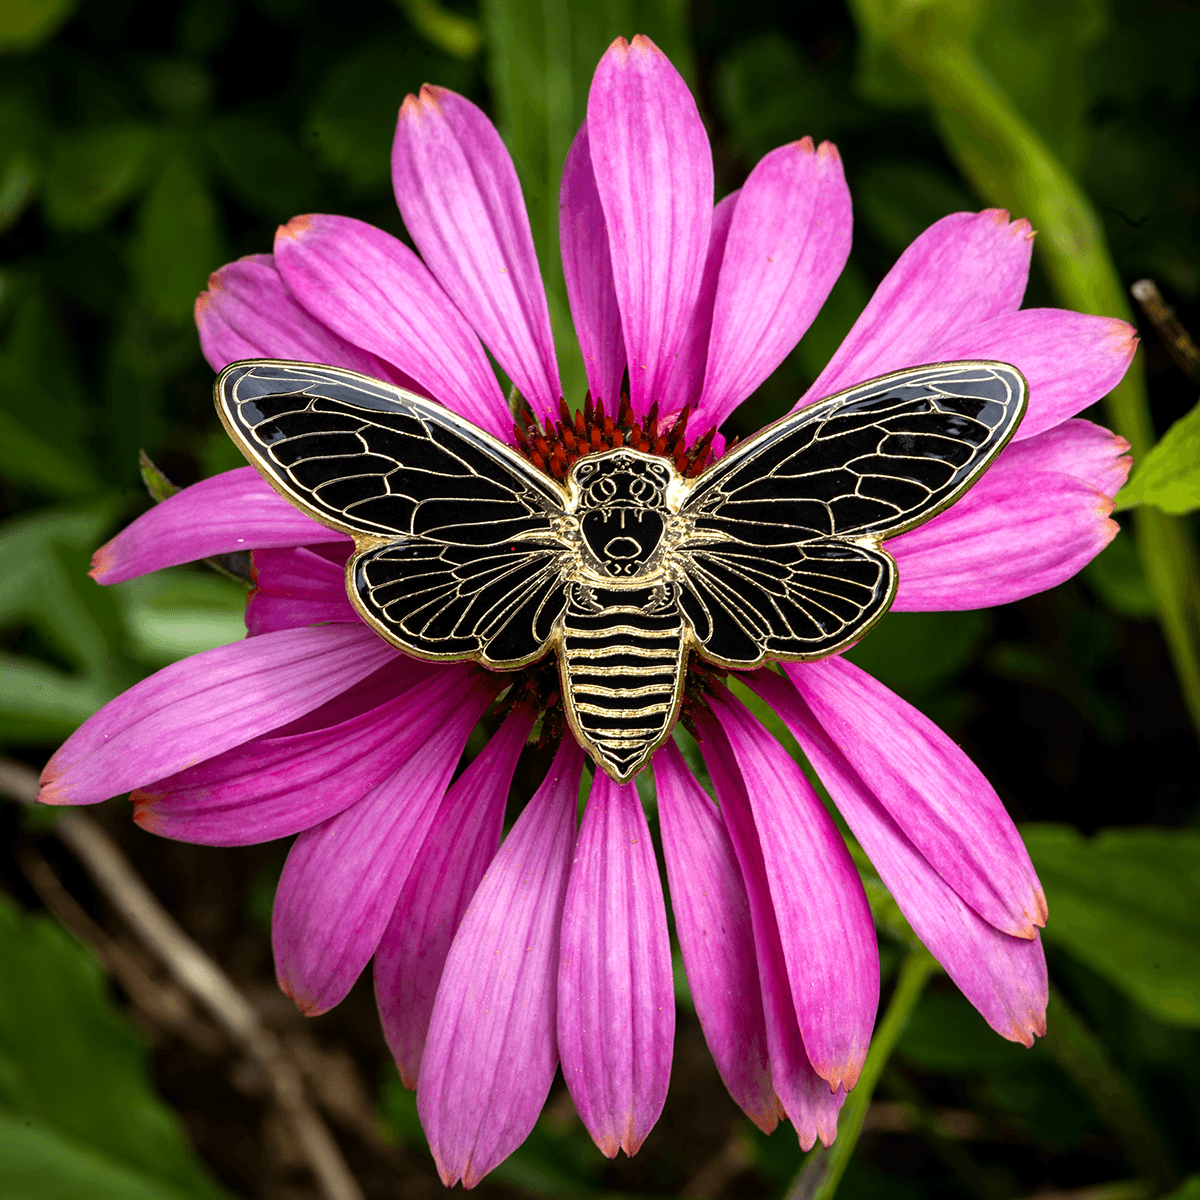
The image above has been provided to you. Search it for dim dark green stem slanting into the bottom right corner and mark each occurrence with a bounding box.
[1043,986,1175,1193]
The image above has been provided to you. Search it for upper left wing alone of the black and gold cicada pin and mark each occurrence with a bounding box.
[216,361,563,546]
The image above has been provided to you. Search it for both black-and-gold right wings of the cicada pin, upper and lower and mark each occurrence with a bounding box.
[677,361,1026,667]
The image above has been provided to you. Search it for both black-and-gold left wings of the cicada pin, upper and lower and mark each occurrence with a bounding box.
[216,361,565,667]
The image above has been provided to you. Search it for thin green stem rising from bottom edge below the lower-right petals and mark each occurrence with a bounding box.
[784,947,937,1200]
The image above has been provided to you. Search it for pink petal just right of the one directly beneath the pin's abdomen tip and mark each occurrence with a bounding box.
[654,740,779,1133]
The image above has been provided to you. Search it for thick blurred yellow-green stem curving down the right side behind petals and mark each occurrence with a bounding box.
[851,0,1200,733]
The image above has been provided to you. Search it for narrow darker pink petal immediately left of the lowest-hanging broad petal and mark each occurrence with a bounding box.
[374,707,534,1088]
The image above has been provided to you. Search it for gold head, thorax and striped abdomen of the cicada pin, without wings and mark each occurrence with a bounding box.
[559,450,688,780]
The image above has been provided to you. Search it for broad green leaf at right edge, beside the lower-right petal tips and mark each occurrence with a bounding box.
[1021,824,1200,1028]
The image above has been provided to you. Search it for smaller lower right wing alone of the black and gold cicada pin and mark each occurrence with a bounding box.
[679,539,895,668]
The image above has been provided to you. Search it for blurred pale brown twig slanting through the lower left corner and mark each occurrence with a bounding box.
[0,760,364,1200]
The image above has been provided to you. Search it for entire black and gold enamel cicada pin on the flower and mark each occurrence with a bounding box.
[216,360,1026,781]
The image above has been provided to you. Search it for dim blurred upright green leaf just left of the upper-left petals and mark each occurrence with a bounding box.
[133,149,228,325]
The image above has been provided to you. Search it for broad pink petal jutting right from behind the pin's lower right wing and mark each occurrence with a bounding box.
[887,463,1118,612]
